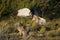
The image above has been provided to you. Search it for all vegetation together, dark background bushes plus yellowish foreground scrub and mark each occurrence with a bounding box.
[0,0,60,40]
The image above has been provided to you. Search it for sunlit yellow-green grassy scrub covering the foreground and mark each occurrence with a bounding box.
[0,16,60,40]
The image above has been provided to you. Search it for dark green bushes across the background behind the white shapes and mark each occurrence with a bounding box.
[0,0,60,19]
